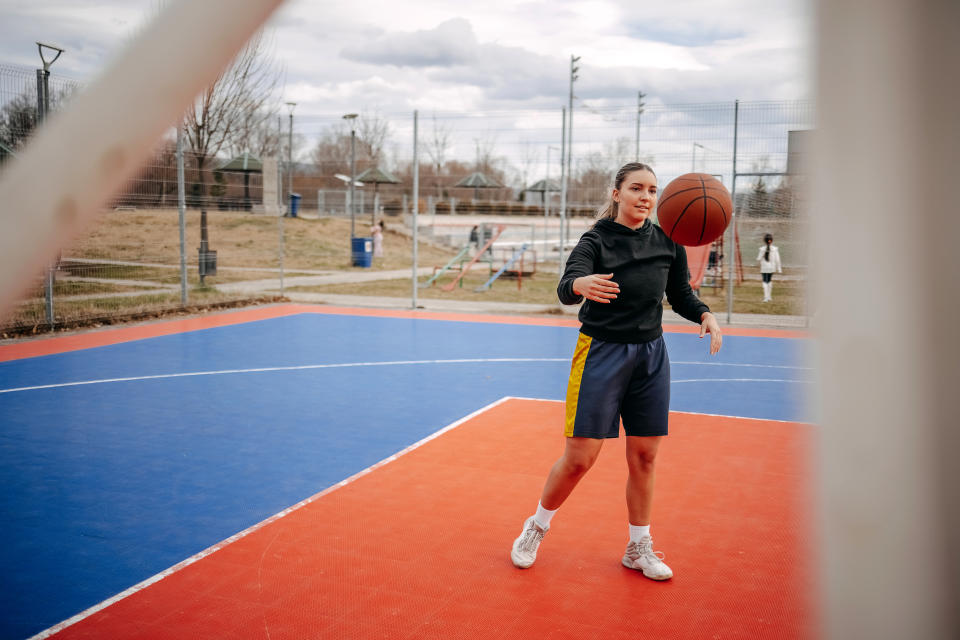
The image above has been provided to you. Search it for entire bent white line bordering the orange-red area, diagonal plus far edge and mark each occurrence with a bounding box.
[28,396,815,640]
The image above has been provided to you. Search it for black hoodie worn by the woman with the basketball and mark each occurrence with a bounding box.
[557,220,710,342]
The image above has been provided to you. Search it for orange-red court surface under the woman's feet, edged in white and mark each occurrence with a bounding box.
[48,398,817,640]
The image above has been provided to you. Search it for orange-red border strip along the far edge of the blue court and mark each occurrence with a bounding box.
[0,303,811,362]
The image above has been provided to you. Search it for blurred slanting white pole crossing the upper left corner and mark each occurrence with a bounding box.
[0,0,281,318]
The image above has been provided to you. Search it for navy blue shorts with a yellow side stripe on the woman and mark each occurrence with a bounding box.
[564,333,670,438]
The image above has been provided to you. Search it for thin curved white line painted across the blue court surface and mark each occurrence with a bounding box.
[0,358,812,393]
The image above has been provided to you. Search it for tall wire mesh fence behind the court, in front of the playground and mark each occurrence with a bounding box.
[0,58,814,331]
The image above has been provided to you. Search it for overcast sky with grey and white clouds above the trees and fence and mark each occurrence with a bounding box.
[0,0,811,175]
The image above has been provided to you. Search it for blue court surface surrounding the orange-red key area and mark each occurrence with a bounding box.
[0,312,813,638]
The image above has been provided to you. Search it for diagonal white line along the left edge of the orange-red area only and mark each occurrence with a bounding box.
[29,396,513,640]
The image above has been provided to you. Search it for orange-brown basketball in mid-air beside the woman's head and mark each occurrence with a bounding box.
[657,173,733,247]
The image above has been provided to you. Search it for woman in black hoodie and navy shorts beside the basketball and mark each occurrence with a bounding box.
[510,163,722,580]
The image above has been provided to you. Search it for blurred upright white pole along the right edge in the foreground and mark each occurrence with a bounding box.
[810,0,960,640]
